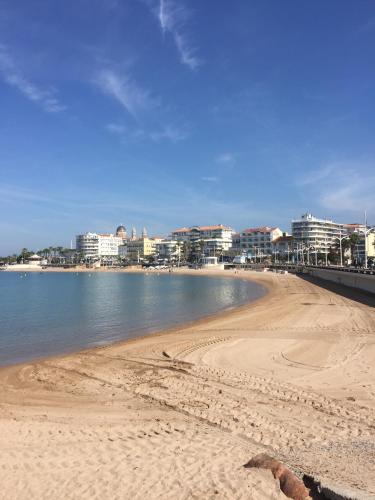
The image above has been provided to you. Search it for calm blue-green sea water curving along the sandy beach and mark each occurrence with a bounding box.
[0,272,264,365]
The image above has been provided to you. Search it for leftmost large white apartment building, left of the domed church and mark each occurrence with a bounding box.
[76,232,123,259]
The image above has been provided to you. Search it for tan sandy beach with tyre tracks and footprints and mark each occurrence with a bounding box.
[0,272,375,500]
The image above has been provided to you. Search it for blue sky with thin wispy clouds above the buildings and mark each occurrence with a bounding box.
[0,0,375,255]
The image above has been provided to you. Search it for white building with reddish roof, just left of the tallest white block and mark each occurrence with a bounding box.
[237,226,283,257]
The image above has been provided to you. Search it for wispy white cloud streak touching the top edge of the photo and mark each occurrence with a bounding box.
[153,0,202,70]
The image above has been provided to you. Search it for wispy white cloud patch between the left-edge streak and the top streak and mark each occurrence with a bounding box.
[95,69,159,118]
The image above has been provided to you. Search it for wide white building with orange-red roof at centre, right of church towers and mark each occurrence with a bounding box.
[171,224,234,255]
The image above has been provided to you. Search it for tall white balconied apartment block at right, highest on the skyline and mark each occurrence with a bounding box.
[292,213,348,254]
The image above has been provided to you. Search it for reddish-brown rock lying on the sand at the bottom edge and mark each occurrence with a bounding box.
[244,453,311,500]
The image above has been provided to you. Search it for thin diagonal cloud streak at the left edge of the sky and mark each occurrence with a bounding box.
[0,45,66,113]
